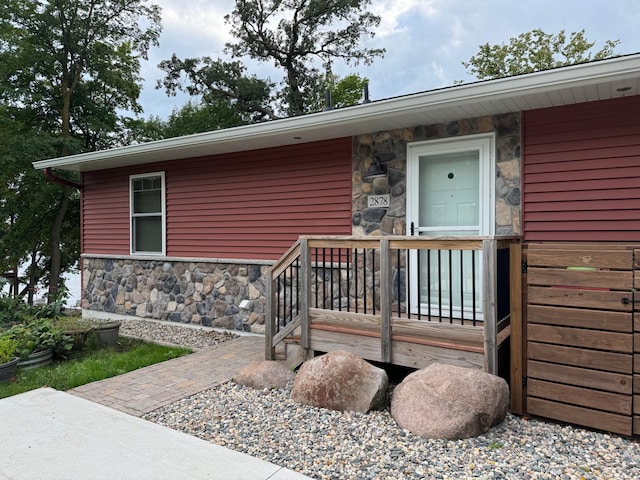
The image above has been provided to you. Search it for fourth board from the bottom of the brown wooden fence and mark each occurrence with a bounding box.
[527,342,633,375]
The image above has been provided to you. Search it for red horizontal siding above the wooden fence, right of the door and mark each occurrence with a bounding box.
[522,96,640,241]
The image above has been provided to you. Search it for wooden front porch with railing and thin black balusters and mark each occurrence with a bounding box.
[266,237,521,373]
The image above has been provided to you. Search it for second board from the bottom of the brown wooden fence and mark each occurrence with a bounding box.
[527,379,640,415]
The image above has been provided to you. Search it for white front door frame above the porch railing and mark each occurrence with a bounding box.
[406,133,496,236]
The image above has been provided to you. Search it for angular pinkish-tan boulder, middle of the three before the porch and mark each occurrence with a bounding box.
[291,350,389,412]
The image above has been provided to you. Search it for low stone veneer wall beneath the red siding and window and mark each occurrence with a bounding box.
[81,257,269,332]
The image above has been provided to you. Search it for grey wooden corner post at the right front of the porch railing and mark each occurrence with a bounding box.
[482,238,498,375]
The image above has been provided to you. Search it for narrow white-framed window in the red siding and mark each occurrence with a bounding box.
[130,172,165,255]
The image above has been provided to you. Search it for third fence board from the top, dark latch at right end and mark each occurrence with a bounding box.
[528,286,633,312]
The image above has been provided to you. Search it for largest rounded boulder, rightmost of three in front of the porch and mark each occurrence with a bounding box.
[391,363,509,440]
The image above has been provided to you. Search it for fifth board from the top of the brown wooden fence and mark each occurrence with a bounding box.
[528,323,633,353]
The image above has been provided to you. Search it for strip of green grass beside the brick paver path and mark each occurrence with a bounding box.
[0,337,191,398]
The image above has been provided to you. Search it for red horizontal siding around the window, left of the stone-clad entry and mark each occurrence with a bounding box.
[83,138,351,259]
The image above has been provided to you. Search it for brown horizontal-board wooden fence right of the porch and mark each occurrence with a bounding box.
[523,244,640,435]
